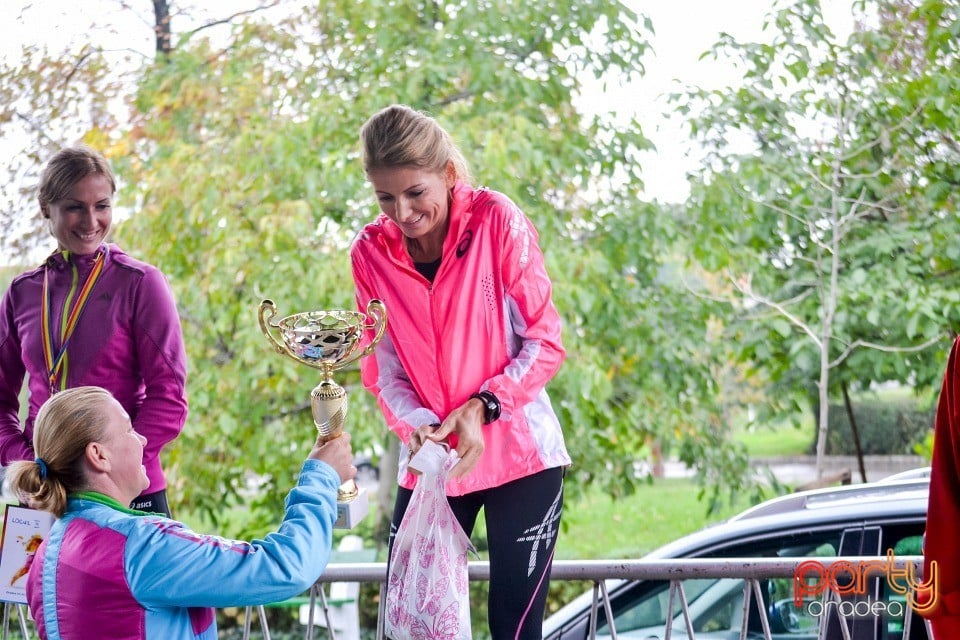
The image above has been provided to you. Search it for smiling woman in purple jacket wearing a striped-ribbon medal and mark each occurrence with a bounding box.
[0,145,187,516]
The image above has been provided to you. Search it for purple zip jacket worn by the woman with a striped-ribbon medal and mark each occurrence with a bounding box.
[0,244,187,494]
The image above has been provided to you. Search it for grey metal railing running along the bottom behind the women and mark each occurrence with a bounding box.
[2,556,932,640]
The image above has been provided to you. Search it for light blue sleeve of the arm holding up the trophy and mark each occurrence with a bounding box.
[124,459,340,608]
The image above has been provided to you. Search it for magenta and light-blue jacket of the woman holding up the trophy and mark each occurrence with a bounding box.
[27,459,340,640]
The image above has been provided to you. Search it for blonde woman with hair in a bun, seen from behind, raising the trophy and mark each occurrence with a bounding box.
[8,387,356,640]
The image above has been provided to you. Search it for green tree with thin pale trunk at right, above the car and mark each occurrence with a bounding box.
[675,0,960,476]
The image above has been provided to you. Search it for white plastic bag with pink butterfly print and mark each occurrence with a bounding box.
[386,441,474,640]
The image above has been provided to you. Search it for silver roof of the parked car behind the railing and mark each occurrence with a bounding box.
[645,474,930,559]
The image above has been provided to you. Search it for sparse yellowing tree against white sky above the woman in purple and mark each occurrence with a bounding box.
[0,0,281,261]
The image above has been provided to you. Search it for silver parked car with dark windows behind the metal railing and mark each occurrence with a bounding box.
[543,470,929,640]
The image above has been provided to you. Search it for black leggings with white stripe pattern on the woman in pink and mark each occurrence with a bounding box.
[389,467,563,640]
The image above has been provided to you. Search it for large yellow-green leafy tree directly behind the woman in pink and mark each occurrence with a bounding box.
[114,1,680,530]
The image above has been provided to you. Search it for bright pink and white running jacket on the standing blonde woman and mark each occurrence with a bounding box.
[351,183,570,496]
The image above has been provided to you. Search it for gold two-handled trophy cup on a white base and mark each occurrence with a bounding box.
[260,300,387,529]
